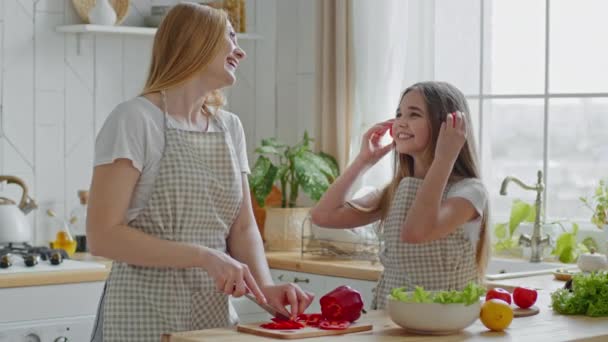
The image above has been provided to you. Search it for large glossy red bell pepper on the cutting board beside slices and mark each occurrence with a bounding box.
[320,285,363,322]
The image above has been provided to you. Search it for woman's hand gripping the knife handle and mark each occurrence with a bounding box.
[203,248,266,303]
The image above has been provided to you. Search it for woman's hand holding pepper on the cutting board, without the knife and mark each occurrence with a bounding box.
[262,283,315,319]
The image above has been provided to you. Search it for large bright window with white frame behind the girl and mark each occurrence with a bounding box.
[433,0,608,222]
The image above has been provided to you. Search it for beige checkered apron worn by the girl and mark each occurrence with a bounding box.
[372,177,478,309]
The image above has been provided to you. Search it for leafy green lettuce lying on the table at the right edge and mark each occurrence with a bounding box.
[551,272,608,317]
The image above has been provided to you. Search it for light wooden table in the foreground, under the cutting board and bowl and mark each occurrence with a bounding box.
[163,282,608,342]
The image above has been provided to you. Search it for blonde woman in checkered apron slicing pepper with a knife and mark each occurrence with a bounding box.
[87,3,313,341]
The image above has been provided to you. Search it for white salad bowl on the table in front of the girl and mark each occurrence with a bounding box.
[387,293,481,335]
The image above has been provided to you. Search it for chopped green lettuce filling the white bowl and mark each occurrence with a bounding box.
[391,282,486,306]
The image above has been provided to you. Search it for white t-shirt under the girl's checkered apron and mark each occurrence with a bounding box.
[346,178,488,245]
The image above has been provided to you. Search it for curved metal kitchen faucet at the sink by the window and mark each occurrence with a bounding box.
[500,170,551,262]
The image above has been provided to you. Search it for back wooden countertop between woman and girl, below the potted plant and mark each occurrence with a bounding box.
[266,252,383,281]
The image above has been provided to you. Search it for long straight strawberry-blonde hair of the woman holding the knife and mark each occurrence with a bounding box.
[142,3,228,109]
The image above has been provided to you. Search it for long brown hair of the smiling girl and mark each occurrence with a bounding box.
[380,82,490,276]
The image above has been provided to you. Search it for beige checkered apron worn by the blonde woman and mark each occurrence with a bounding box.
[93,106,243,342]
